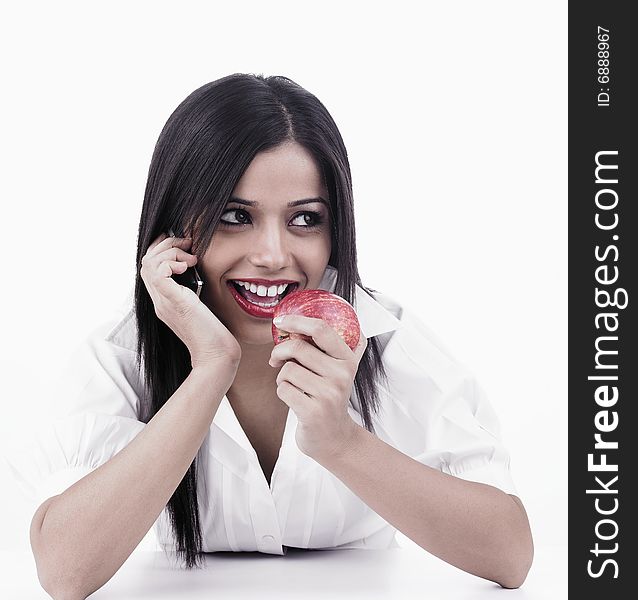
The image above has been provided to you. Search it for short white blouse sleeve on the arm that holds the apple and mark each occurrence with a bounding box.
[381,302,517,494]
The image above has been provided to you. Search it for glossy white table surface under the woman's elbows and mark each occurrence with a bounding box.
[0,542,567,600]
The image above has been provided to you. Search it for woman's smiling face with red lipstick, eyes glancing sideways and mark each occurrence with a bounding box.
[197,142,331,345]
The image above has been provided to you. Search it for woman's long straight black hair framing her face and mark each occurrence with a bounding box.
[135,74,387,569]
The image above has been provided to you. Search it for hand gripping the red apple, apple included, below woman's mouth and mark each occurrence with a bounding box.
[269,290,367,462]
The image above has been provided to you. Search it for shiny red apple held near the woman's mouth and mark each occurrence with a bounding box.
[272,290,360,350]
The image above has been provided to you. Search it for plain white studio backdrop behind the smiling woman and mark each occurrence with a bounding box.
[0,0,567,584]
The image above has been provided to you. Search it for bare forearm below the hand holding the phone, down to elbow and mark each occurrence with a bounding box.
[31,369,235,598]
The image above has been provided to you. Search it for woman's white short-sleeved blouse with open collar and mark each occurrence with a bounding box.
[8,266,516,554]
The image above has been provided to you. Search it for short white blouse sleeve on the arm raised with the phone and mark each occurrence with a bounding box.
[5,304,145,506]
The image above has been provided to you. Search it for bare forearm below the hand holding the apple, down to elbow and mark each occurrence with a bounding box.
[315,424,533,587]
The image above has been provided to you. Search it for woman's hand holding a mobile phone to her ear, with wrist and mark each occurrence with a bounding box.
[140,233,241,369]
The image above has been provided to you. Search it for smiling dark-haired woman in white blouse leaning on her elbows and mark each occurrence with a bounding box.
[18,75,533,597]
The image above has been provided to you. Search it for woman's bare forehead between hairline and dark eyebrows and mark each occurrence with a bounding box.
[233,142,327,204]
